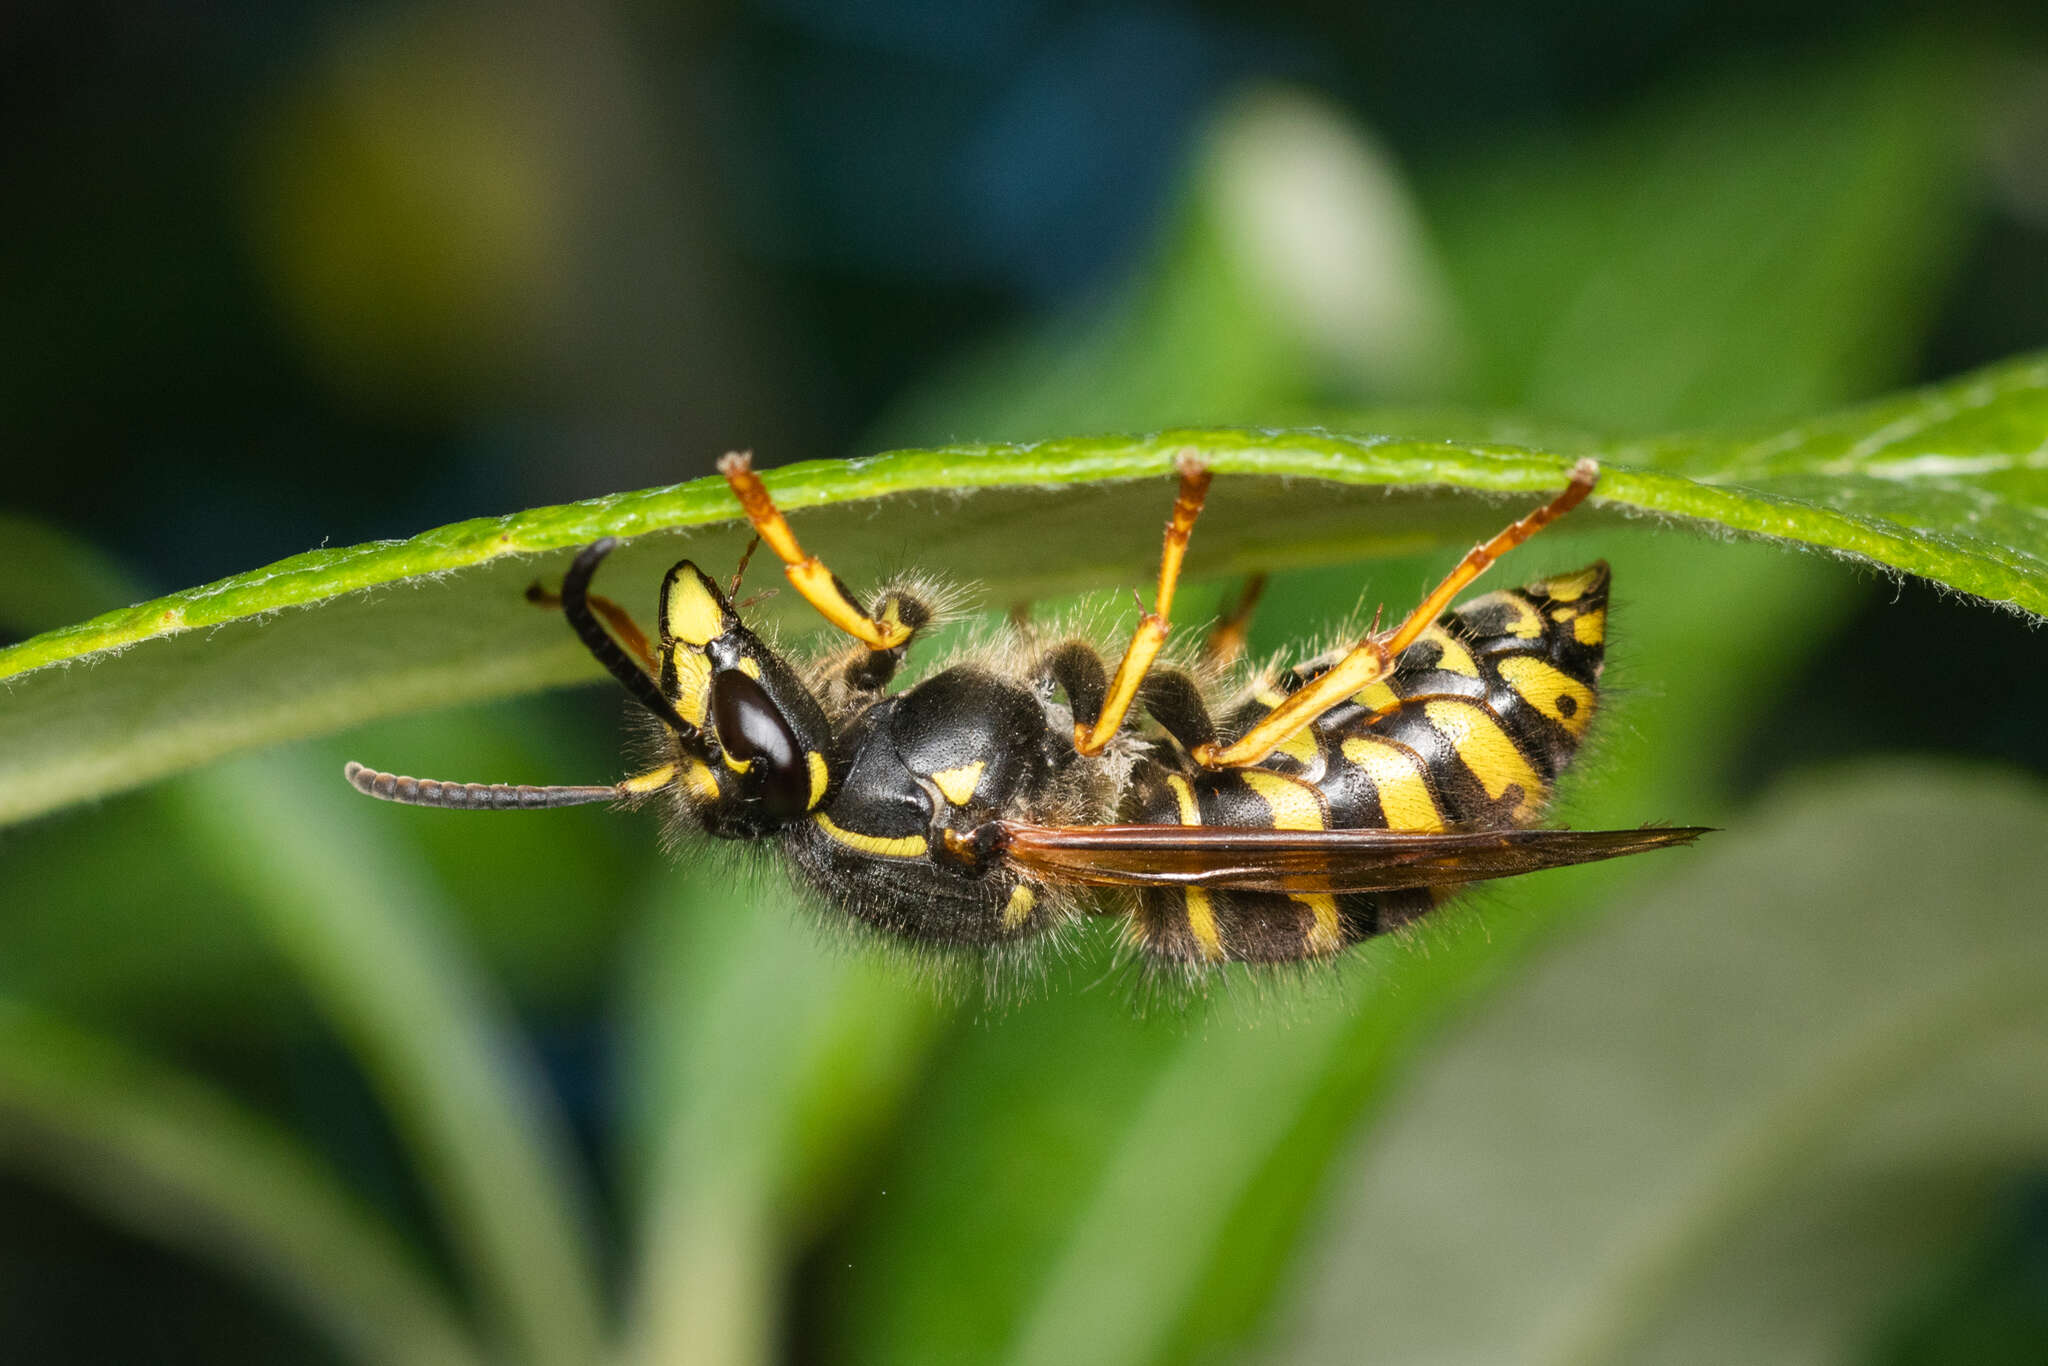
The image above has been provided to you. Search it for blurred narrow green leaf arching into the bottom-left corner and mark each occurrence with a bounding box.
[0,1004,485,1366]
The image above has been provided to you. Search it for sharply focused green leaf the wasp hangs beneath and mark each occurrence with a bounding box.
[0,356,2048,819]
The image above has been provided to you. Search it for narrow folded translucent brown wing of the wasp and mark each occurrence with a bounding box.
[995,821,1708,893]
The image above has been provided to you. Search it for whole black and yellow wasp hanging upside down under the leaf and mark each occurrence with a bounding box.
[346,455,1704,973]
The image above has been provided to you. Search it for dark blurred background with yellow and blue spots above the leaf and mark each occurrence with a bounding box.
[0,0,2048,590]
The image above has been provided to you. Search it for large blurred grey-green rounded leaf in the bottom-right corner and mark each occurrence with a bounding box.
[1272,766,2048,1366]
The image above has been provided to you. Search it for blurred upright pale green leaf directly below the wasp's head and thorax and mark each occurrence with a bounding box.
[623,864,940,1366]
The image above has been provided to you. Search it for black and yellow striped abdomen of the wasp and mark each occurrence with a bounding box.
[1137,563,1608,963]
